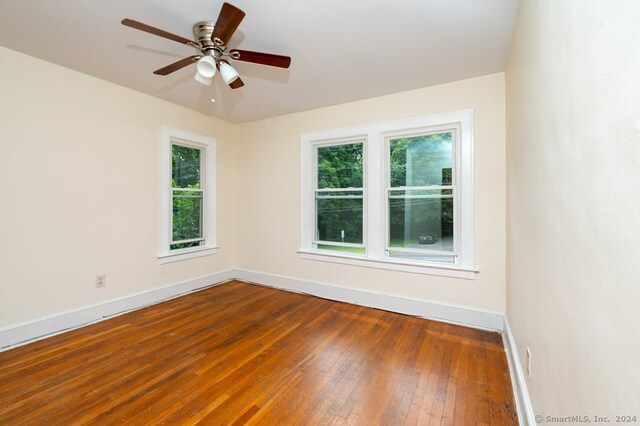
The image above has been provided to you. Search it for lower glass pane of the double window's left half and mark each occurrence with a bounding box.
[316,193,362,244]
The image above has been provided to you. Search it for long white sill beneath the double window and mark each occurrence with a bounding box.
[298,250,478,280]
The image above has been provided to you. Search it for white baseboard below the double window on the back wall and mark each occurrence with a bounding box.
[235,269,504,332]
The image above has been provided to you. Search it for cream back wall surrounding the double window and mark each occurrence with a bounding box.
[237,73,505,311]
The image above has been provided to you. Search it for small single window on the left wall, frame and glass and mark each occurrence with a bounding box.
[158,126,216,263]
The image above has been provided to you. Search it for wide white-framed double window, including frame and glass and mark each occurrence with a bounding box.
[300,110,475,278]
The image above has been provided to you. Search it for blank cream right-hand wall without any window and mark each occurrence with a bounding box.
[506,0,640,416]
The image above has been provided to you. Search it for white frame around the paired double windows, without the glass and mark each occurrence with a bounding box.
[298,109,478,279]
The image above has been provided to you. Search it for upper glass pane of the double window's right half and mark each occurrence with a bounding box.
[389,132,453,187]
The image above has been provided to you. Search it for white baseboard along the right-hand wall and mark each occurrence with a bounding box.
[502,316,536,426]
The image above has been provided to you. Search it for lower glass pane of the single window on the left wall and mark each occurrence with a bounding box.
[173,191,202,241]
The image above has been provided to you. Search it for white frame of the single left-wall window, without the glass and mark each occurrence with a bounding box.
[158,126,219,263]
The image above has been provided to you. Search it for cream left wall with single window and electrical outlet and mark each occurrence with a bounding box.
[0,48,236,327]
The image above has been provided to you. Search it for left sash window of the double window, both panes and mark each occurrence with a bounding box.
[314,142,365,253]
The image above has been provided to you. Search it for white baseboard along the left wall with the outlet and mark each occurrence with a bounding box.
[0,269,235,350]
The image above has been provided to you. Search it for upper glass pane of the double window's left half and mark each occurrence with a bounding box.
[318,143,363,189]
